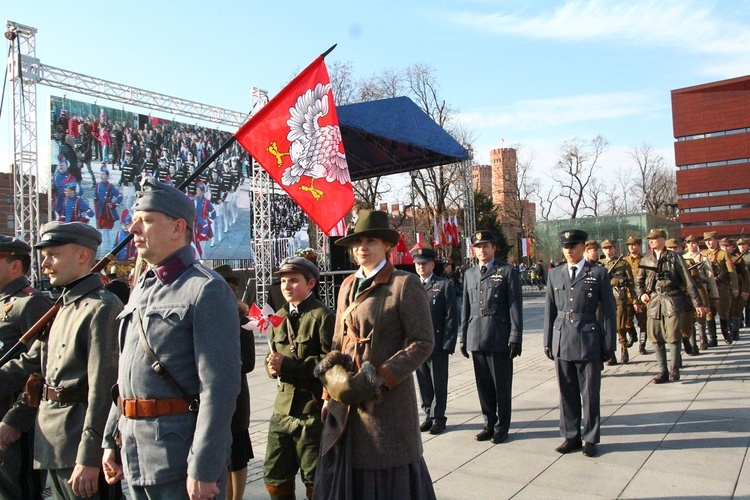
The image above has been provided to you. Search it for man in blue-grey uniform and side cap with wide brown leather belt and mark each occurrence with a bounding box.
[103,178,240,499]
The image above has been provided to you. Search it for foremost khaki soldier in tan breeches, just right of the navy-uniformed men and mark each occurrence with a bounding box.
[635,229,706,384]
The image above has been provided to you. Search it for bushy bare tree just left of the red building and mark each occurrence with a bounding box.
[628,142,677,216]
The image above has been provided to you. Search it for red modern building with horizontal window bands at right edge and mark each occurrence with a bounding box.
[672,76,750,237]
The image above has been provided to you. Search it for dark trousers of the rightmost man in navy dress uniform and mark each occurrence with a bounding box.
[555,358,602,443]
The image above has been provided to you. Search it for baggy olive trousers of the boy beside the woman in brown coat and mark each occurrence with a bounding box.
[263,412,323,486]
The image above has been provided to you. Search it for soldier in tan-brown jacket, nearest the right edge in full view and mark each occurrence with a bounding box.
[701,231,740,347]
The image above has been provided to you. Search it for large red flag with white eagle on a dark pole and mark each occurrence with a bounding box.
[234,56,354,234]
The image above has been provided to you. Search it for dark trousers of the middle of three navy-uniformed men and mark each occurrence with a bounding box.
[471,351,513,432]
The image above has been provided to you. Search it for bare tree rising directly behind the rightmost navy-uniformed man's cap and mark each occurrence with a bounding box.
[552,135,609,219]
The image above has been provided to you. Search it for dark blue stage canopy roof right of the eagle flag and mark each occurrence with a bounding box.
[336,97,468,180]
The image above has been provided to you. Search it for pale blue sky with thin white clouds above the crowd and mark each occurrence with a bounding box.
[0,0,750,215]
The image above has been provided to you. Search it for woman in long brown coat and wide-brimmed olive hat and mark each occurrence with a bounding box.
[313,210,435,499]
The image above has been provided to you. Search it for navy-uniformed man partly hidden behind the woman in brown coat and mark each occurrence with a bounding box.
[412,248,458,434]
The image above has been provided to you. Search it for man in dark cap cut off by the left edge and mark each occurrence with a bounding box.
[0,236,52,498]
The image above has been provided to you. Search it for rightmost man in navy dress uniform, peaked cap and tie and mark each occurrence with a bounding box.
[543,229,617,457]
